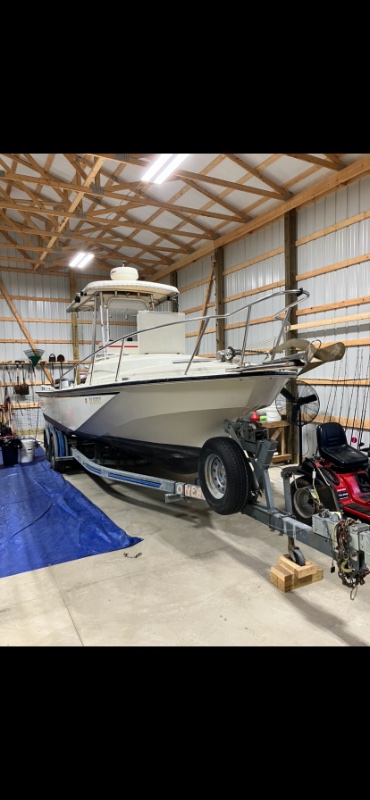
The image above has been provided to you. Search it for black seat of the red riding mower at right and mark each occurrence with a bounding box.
[316,422,369,472]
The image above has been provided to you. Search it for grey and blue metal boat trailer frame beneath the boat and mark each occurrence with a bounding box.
[44,420,370,599]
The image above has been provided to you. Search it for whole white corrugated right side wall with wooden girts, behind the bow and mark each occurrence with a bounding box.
[178,178,370,456]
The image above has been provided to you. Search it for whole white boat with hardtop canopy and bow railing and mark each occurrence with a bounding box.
[37,268,326,464]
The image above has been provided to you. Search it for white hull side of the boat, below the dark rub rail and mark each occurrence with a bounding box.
[39,370,295,451]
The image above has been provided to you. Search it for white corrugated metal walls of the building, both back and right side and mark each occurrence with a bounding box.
[0,178,370,455]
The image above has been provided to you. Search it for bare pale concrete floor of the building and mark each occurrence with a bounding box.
[0,456,370,647]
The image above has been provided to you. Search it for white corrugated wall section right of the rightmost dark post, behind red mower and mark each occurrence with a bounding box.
[297,178,370,454]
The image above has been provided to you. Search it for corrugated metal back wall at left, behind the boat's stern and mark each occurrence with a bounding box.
[0,264,106,439]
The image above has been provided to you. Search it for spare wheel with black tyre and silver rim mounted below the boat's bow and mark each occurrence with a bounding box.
[198,436,248,514]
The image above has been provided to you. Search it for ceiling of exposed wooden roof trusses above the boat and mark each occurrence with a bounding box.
[0,153,366,280]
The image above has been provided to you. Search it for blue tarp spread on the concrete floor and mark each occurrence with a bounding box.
[0,446,142,578]
